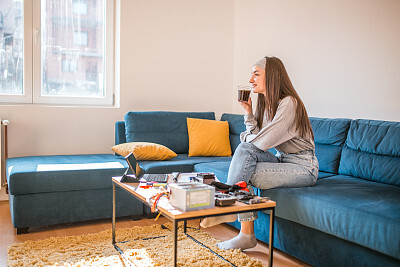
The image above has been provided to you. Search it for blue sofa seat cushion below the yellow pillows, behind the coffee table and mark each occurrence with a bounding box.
[139,154,232,173]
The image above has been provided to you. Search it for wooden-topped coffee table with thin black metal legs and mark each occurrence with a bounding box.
[112,177,276,266]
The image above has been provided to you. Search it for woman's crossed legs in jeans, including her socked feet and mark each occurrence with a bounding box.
[201,143,316,249]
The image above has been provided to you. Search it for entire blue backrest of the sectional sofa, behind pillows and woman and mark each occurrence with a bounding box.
[115,111,400,186]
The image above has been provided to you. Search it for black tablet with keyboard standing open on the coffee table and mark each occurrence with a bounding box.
[121,153,168,183]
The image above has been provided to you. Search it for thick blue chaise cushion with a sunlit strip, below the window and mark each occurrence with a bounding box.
[6,154,128,195]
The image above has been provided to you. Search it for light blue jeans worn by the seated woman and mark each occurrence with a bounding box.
[227,143,319,222]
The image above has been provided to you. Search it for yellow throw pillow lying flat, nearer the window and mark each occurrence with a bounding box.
[111,142,177,160]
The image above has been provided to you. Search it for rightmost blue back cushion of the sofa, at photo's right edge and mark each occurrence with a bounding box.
[339,120,400,186]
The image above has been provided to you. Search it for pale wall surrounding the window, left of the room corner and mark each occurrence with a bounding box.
[0,0,234,157]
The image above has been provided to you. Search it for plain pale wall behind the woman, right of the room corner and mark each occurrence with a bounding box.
[233,0,400,121]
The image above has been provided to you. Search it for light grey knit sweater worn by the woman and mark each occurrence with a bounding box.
[240,96,315,153]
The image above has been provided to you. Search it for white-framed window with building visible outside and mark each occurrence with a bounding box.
[0,0,115,105]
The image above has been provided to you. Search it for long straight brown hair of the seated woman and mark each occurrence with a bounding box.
[255,57,314,139]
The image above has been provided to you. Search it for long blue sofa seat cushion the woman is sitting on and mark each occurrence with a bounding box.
[261,175,400,259]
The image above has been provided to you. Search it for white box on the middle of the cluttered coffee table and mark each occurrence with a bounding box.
[168,182,215,211]
